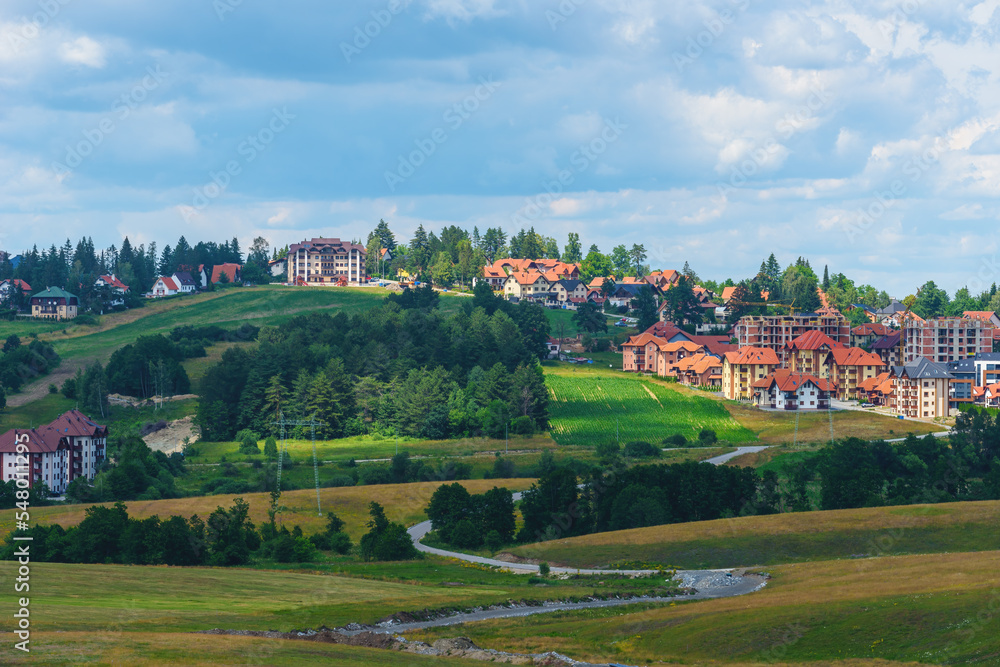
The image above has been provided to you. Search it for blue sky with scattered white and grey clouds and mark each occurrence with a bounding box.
[0,0,1000,296]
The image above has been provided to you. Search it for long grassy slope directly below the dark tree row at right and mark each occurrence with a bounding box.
[511,501,1000,569]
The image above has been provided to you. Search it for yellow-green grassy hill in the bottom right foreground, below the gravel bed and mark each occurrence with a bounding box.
[414,552,1000,666]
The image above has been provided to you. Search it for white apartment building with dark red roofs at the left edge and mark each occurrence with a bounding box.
[0,410,108,495]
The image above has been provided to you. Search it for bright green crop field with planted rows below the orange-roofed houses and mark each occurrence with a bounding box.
[545,365,756,447]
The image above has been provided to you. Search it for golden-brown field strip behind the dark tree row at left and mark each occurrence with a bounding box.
[0,479,534,541]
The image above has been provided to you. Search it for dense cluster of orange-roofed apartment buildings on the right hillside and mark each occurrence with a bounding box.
[622,288,1000,419]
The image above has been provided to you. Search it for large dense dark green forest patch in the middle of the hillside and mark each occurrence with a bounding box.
[198,286,549,441]
